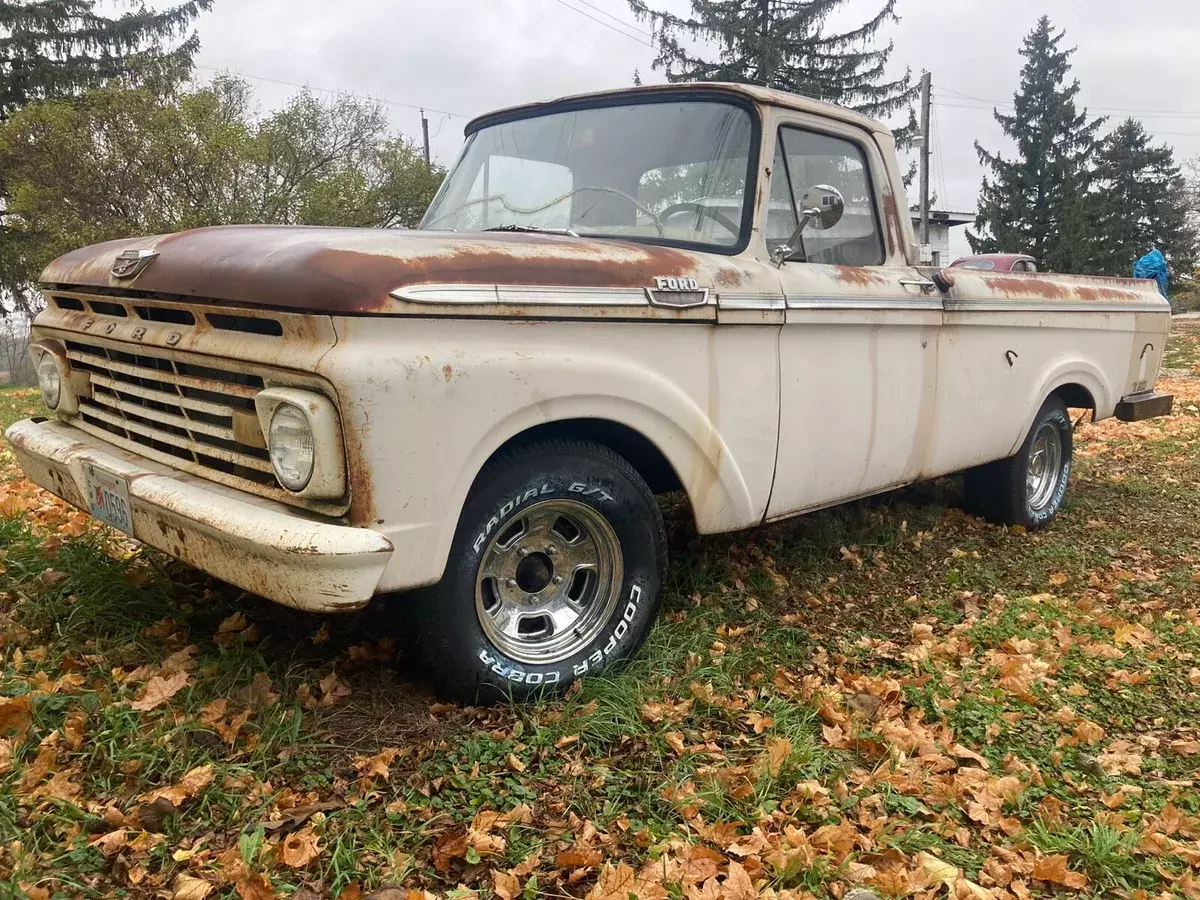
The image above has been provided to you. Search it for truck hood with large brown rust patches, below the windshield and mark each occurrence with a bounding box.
[41,226,751,313]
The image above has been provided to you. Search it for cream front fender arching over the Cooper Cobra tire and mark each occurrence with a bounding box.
[320,318,778,589]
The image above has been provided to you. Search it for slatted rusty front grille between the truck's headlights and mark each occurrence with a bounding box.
[66,341,276,487]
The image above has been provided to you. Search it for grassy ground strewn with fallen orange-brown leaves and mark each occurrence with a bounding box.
[0,330,1200,900]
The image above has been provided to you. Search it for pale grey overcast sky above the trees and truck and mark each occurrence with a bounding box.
[187,0,1200,256]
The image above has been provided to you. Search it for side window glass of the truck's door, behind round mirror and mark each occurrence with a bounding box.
[766,126,884,265]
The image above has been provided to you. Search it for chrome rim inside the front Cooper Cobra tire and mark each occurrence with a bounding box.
[475,499,624,664]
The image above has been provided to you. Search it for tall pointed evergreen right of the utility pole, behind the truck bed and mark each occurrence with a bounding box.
[967,16,1104,271]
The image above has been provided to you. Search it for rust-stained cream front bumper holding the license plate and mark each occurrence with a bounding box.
[6,419,392,612]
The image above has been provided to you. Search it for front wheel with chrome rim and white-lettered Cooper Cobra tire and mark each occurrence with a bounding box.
[401,440,666,703]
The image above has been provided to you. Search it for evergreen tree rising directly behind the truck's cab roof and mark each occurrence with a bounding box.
[629,0,917,119]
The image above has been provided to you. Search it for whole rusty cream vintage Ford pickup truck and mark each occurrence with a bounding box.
[7,84,1171,700]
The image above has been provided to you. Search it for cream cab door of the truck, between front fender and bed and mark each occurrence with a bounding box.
[766,119,942,518]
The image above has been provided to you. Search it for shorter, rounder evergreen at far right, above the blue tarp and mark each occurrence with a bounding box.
[1088,119,1196,282]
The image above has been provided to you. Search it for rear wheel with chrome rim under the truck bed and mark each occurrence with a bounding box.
[966,397,1073,530]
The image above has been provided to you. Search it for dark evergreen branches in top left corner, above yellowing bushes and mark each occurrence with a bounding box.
[0,0,212,121]
